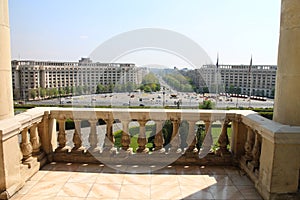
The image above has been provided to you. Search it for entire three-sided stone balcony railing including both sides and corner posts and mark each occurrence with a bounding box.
[0,108,300,199]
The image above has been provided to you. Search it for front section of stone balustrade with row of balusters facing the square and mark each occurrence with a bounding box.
[48,109,236,165]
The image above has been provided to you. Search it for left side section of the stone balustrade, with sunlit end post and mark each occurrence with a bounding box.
[0,108,48,199]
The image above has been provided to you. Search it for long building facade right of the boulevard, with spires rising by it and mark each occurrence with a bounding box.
[191,65,277,97]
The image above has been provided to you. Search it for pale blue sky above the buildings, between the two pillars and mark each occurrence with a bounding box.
[9,0,281,67]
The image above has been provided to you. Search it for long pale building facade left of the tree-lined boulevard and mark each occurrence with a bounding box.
[11,58,141,99]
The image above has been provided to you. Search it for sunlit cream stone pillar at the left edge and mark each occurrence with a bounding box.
[0,0,14,120]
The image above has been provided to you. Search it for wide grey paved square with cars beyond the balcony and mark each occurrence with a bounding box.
[32,90,274,108]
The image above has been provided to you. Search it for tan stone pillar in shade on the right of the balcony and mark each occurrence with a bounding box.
[273,0,300,126]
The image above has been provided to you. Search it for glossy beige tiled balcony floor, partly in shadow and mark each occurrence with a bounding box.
[11,163,262,200]
